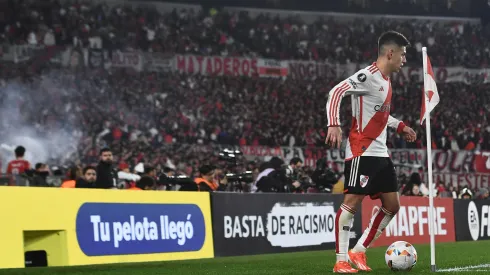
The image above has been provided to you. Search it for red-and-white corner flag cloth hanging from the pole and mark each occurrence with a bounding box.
[420,51,440,125]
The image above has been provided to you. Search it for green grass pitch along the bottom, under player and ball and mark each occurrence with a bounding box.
[0,241,490,275]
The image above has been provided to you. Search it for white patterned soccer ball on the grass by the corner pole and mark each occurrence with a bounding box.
[385,241,417,271]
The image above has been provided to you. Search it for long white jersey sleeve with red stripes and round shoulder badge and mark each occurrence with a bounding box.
[326,69,373,127]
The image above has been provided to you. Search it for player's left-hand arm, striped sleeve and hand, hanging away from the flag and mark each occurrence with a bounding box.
[325,70,372,148]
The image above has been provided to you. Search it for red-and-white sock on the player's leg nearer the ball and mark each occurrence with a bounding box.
[352,207,395,252]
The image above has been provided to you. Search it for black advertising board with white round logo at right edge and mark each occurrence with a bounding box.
[454,200,490,241]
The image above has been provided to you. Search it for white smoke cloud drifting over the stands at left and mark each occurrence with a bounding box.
[0,75,81,172]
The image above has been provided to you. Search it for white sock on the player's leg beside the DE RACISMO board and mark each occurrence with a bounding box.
[335,204,356,262]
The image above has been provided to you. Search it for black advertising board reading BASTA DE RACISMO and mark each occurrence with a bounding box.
[211,193,361,256]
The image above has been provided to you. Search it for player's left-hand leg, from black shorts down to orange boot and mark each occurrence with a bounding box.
[333,157,365,273]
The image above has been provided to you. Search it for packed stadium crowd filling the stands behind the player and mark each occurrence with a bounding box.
[0,1,490,198]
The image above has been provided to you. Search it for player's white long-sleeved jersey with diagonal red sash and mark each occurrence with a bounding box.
[327,63,405,160]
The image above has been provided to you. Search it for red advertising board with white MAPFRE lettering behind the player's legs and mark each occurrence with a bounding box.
[362,197,455,247]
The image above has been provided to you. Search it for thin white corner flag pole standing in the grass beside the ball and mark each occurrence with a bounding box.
[422,47,437,272]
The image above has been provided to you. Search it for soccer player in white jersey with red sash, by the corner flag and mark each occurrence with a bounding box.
[325,31,417,273]
